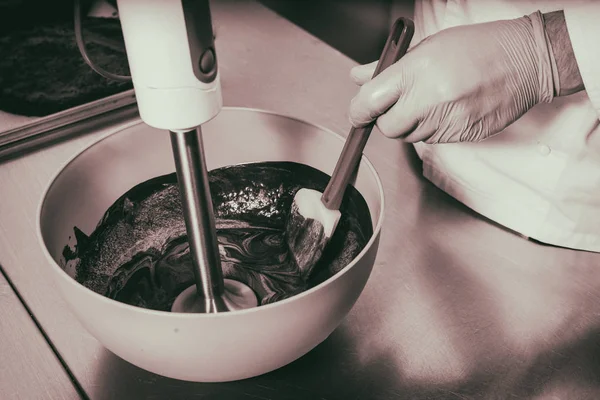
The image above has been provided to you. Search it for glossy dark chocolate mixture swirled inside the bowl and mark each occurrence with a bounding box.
[63,162,373,311]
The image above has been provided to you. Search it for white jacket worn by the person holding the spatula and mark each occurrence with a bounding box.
[396,0,600,252]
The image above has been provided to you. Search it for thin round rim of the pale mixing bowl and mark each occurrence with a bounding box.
[36,106,385,318]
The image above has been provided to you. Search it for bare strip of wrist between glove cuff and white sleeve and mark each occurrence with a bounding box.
[544,10,585,96]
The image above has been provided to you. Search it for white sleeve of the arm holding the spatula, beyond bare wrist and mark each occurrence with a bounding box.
[563,0,600,117]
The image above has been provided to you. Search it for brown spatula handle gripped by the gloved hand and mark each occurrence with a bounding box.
[321,18,415,210]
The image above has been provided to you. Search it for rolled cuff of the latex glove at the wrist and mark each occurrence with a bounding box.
[527,10,560,103]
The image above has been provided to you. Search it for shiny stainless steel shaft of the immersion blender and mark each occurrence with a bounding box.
[170,127,227,313]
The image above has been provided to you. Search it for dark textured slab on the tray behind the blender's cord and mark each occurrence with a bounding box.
[0,15,133,117]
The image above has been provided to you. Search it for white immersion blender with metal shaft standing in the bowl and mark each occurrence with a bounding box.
[117,0,258,313]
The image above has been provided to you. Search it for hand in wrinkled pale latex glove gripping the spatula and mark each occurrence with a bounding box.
[349,12,560,143]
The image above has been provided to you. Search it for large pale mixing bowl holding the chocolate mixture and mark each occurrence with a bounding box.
[38,108,384,382]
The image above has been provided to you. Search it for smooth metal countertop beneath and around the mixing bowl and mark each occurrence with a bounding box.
[0,1,600,400]
